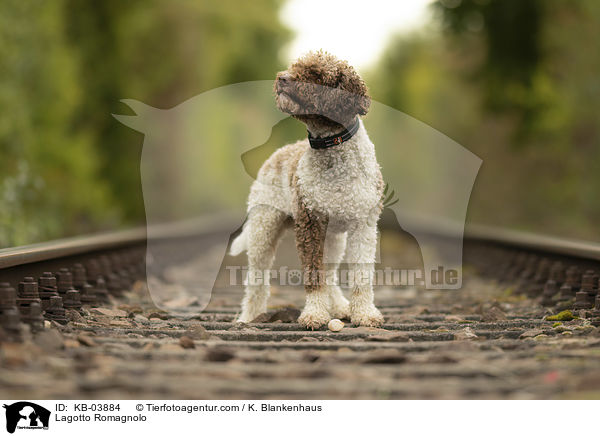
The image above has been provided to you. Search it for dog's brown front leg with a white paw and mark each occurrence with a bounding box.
[295,203,330,330]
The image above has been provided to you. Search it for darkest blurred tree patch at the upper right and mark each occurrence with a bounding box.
[433,0,549,138]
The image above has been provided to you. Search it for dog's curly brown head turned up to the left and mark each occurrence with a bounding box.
[275,51,371,126]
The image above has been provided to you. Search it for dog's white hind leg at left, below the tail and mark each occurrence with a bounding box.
[237,205,288,322]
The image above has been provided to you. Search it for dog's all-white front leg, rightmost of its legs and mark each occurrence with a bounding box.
[346,223,383,327]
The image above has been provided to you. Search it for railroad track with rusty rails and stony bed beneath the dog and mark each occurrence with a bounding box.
[0,219,600,399]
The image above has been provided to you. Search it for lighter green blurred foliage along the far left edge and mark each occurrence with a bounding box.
[0,0,117,246]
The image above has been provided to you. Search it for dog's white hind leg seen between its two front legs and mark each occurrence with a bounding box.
[324,231,350,319]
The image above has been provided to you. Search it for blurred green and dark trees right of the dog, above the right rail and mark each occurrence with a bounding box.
[368,0,600,239]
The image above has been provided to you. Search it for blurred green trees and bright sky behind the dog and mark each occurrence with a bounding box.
[0,0,600,248]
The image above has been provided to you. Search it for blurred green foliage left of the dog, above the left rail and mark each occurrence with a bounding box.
[0,0,290,246]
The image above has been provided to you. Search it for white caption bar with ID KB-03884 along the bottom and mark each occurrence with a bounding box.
[2,400,598,436]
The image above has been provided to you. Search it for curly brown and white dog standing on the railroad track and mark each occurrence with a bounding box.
[231,51,384,329]
